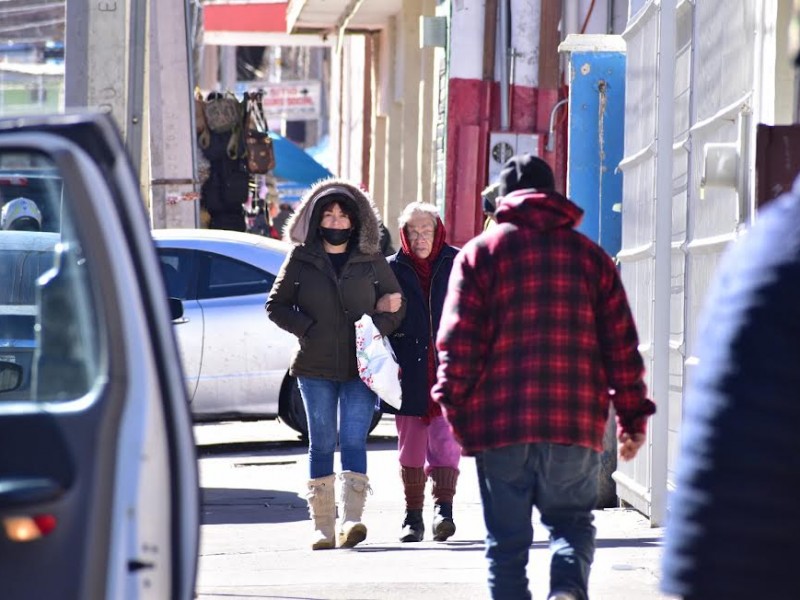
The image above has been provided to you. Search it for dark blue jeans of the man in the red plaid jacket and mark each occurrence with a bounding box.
[476,443,600,600]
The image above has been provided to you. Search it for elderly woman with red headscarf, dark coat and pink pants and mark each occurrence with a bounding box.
[384,202,461,542]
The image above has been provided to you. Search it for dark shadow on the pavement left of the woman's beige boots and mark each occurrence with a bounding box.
[200,488,308,525]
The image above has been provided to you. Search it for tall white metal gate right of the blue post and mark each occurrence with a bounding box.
[614,0,780,524]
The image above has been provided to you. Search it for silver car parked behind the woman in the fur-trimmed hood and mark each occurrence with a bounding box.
[153,229,380,437]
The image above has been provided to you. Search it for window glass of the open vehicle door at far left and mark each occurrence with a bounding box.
[0,151,102,402]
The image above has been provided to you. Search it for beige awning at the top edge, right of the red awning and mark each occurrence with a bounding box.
[286,0,403,35]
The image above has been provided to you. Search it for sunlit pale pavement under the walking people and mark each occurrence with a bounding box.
[195,417,669,600]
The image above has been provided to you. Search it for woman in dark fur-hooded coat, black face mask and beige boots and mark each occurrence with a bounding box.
[266,179,405,550]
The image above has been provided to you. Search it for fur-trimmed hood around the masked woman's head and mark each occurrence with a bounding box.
[283,177,381,254]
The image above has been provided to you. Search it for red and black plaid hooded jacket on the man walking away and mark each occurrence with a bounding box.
[433,190,655,454]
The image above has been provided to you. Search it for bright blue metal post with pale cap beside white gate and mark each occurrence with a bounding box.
[567,51,625,256]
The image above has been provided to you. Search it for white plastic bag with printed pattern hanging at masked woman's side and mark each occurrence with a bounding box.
[355,315,402,410]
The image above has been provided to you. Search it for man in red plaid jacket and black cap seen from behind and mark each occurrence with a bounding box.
[433,155,655,600]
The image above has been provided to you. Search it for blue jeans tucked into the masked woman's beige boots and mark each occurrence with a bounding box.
[297,377,376,479]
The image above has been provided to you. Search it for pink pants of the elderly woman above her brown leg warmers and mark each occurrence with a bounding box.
[394,415,461,475]
